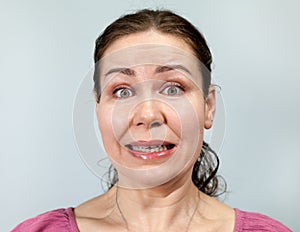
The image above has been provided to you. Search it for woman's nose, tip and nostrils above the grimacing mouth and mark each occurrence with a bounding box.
[133,100,165,129]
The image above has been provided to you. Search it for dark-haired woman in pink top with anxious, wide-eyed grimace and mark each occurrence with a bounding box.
[13,10,290,232]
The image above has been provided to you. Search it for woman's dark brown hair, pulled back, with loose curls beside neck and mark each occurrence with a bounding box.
[94,9,226,196]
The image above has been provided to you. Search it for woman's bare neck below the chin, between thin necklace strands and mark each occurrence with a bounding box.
[114,172,199,231]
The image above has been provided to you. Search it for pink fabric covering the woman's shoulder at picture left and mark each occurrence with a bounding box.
[12,208,79,232]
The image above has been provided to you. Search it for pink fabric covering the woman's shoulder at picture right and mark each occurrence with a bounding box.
[234,209,291,232]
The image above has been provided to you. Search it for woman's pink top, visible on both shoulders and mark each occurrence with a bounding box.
[11,208,291,232]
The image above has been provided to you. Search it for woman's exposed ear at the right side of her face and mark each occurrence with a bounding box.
[204,85,216,129]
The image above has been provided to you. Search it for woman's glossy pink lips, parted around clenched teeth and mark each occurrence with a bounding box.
[125,140,177,160]
